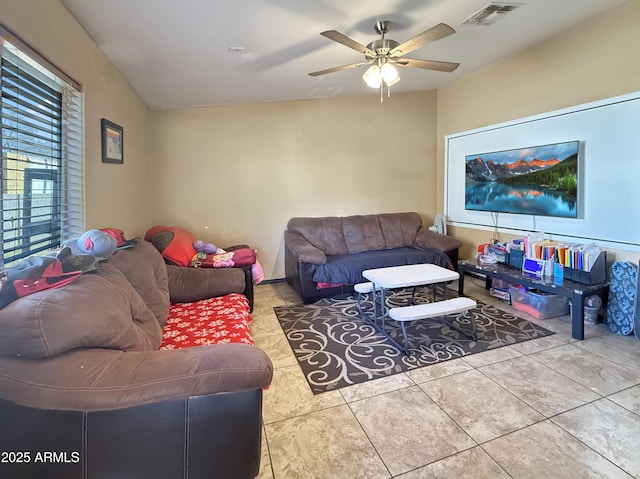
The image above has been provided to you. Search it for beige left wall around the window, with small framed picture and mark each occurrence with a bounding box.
[0,0,151,237]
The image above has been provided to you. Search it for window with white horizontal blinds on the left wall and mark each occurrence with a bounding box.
[0,26,84,265]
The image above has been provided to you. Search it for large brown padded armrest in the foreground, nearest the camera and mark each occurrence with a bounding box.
[0,344,273,411]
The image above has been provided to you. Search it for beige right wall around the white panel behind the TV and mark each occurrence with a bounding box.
[437,0,640,261]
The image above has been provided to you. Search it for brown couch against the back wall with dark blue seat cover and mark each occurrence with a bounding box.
[284,212,462,303]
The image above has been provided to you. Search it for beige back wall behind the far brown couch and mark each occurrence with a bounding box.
[151,91,436,279]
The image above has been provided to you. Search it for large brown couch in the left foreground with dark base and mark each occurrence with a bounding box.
[0,241,272,479]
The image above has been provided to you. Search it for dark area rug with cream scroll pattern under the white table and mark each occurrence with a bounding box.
[274,289,554,394]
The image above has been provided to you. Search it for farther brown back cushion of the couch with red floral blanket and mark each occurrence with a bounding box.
[107,241,169,327]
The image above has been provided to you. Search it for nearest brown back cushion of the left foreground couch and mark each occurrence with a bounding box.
[0,264,161,358]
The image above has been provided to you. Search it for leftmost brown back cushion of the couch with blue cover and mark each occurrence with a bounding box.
[287,216,348,254]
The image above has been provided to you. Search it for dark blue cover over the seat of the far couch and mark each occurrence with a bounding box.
[313,248,451,284]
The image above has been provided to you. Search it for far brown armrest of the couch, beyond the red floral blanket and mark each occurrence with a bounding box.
[167,265,246,303]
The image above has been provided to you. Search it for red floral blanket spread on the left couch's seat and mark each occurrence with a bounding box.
[160,293,254,349]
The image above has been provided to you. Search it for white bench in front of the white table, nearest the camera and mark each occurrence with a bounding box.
[389,297,477,353]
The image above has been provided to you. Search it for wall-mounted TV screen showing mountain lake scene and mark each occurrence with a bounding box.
[464,141,580,218]
